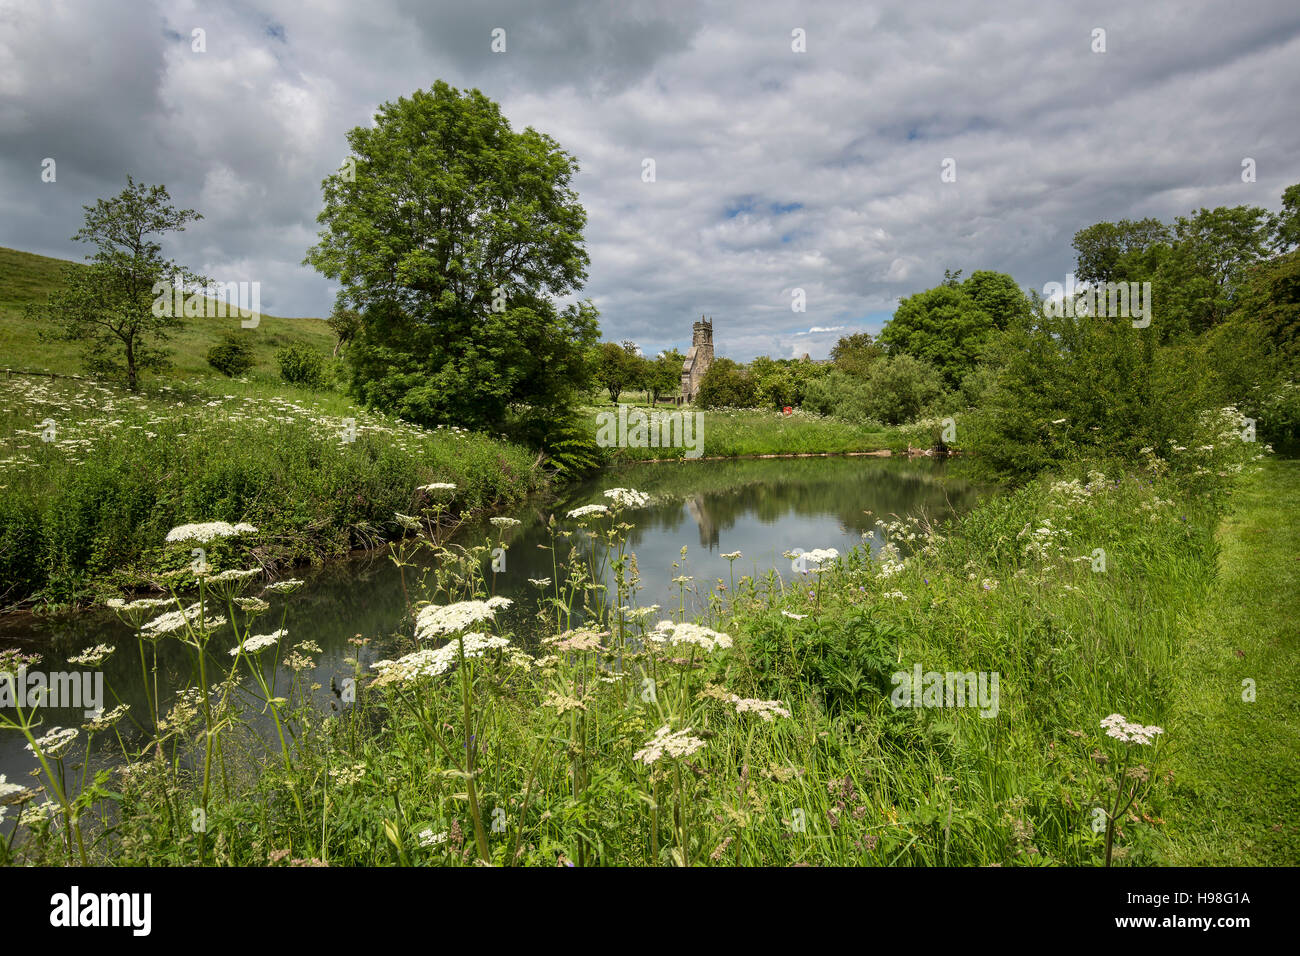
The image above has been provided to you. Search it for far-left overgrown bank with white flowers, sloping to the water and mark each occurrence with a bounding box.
[0,376,549,607]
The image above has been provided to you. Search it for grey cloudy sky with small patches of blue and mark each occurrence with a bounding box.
[0,0,1300,359]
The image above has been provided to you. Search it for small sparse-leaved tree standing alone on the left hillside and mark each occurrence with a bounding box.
[33,177,207,392]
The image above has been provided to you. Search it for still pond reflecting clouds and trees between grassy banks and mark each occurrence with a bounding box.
[0,458,982,780]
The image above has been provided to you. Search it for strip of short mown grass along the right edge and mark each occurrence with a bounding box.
[1165,459,1300,866]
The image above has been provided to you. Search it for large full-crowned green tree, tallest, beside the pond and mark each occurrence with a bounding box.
[307,81,598,432]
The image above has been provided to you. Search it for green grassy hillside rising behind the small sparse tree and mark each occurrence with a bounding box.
[0,246,334,382]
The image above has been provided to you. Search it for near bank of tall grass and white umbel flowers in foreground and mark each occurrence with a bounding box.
[5,442,1274,865]
